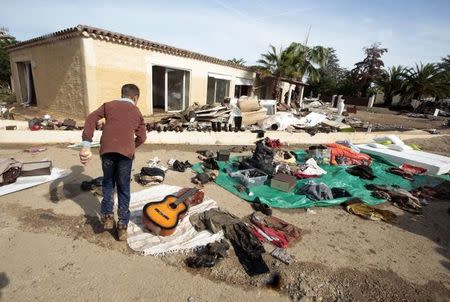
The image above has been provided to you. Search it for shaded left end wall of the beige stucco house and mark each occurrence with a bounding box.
[10,37,85,116]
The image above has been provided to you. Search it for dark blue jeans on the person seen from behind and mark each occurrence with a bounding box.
[101,153,133,225]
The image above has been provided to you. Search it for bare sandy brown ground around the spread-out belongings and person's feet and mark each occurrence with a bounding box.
[0,137,450,301]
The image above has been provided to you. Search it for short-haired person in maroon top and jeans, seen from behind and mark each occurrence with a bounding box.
[79,84,147,241]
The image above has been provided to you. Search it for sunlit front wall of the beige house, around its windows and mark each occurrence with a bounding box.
[83,38,255,115]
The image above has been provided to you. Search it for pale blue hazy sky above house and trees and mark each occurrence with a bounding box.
[0,0,450,68]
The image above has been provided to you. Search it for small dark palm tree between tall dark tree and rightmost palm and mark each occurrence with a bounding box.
[375,65,408,106]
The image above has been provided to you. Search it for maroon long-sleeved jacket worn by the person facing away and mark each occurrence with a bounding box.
[82,100,147,159]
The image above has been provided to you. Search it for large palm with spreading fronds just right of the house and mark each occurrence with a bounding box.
[257,42,328,100]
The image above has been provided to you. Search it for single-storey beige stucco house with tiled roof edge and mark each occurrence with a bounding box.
[8,25,256,116]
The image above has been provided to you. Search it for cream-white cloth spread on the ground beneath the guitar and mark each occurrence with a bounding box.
[127,185,224,256]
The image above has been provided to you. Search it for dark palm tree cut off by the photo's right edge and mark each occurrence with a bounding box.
[405,63,450,100]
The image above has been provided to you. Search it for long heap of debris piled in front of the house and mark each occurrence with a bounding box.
[142,96,368,135]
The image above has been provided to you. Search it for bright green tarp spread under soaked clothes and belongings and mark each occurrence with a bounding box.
[192,151,449,208]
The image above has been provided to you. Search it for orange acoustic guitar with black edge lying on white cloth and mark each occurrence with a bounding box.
[142,188,204,236]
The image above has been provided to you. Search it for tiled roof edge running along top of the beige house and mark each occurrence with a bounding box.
[7,25,252,71]
